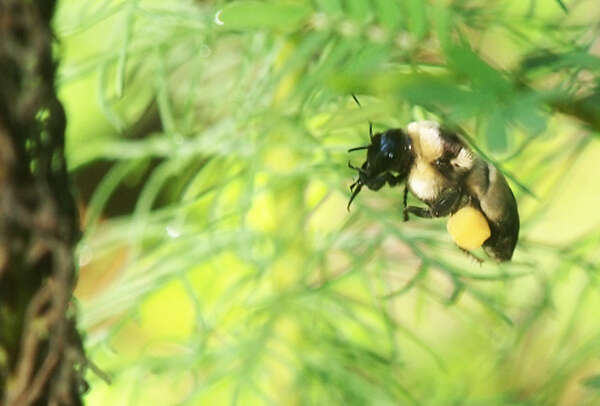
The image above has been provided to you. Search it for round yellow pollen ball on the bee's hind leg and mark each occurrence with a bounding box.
[447,206,492,251]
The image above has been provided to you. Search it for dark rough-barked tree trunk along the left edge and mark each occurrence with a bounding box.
[0,0,85,406]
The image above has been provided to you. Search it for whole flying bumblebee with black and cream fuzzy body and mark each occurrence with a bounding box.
[348,121,519,262]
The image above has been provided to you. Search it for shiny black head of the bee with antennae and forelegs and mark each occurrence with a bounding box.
[348,128,414,209]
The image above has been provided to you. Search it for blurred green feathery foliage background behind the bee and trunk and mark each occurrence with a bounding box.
[54,0,600,406]
